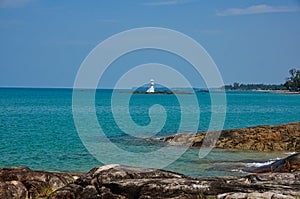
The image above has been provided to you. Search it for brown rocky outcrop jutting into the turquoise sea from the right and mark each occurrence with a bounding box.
[156,122,300,152]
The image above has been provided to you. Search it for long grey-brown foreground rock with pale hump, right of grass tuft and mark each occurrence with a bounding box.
[49,165,300,199]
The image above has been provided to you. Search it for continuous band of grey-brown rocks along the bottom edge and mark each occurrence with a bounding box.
[0,153,300,199]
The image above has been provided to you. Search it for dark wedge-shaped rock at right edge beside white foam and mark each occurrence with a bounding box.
[245,153,300,173]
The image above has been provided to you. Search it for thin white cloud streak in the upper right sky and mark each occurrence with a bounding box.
[217,4,300,16]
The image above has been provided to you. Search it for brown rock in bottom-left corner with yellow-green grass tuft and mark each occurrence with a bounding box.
[0,167,82,199]
